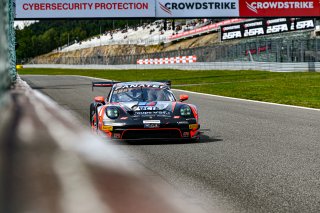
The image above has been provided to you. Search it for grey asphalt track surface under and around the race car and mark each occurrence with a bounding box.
[22,76,320,213]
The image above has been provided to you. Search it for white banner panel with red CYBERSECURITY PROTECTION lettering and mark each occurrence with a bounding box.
[15,0,155,19]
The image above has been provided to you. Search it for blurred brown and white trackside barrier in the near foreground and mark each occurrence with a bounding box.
[0,79,198,213]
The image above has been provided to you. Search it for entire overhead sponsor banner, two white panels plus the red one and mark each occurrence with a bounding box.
[15,0,320,19]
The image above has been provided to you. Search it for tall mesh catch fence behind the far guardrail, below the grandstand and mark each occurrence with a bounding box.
[30,31,320,65]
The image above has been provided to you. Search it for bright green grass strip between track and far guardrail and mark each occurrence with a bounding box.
[19,68,320,108]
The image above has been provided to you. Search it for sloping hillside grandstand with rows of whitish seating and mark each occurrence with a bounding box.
[59,19,246,52]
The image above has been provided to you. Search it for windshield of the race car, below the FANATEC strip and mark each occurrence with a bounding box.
[110,87,175,102]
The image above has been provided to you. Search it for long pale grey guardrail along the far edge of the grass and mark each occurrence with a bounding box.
[24,61,320,72]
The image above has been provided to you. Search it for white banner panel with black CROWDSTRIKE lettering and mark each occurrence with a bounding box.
[156,0,239,18]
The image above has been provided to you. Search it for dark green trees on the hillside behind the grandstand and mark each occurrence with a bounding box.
[15,19,148,63]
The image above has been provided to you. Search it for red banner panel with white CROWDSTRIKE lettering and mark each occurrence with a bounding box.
[239,0,320,17]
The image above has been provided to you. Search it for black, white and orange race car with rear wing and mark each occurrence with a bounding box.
[90,81,200,141]
